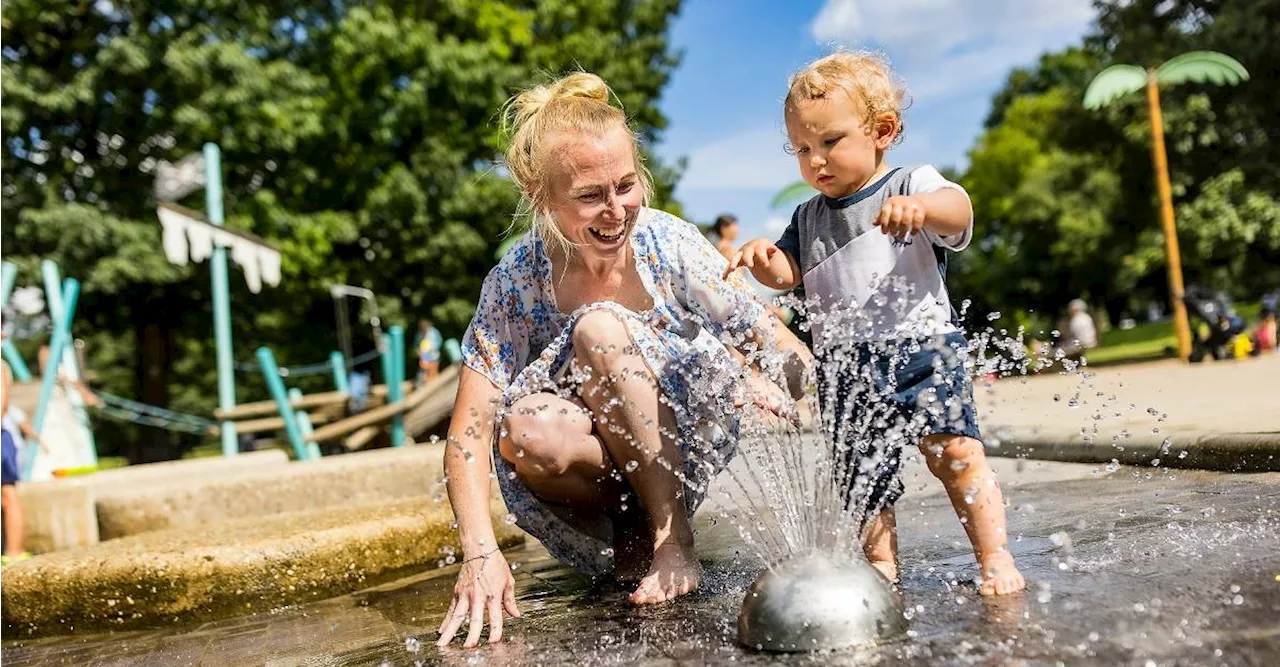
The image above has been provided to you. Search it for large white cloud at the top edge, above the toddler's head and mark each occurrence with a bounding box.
[810,0,1094,101]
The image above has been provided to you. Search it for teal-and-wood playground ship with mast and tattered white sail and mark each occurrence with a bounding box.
[0,143,461,481]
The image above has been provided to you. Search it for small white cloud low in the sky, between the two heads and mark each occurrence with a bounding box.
[680,120,800,189]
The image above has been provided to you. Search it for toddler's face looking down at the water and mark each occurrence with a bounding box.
[786,91,897,197]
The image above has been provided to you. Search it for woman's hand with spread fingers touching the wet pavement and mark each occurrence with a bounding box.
[435,550,520,648]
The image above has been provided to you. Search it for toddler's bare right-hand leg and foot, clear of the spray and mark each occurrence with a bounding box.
[920,434,1027,595]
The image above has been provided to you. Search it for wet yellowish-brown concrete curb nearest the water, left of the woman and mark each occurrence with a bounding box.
[0,498,525,639]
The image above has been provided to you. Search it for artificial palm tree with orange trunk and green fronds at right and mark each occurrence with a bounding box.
[1084,51,1249,361]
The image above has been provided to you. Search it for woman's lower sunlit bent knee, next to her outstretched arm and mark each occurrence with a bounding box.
[498,397,591,475]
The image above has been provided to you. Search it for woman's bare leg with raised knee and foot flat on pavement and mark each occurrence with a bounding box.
[573,311,701,604]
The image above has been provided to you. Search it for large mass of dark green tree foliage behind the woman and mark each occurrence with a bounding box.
[0,0,680,460]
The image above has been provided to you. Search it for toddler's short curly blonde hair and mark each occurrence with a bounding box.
[783,51,911,145]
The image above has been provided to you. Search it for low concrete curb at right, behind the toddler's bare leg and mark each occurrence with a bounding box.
[987,431,1280,472]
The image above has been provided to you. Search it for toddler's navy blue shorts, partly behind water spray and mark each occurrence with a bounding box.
[818,333,982,521]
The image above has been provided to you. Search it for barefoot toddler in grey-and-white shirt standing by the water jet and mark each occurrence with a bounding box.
[726,52,1025,595]
